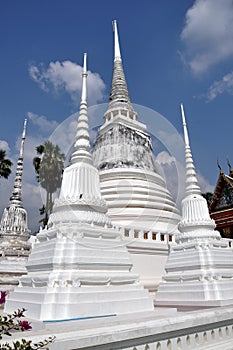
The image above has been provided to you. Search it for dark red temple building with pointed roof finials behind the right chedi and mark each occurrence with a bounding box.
[209,161,233,239]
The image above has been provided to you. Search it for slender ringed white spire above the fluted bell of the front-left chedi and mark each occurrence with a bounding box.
[71,53,92,164]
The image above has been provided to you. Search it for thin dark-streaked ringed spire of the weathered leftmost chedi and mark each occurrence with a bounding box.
[10,119,27,207]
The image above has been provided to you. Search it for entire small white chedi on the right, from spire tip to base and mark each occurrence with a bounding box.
[156,105,233,310]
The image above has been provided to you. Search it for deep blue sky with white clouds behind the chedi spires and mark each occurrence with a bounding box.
[0,0,233,232]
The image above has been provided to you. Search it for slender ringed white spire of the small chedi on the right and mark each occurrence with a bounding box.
[180,104,201,196]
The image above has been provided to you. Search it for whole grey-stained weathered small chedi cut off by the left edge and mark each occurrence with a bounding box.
[0,119,30,290]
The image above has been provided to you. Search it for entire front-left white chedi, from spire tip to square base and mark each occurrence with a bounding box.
[5,54,153,320]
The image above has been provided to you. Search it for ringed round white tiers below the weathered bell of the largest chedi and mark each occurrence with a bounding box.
[100,168,179,233]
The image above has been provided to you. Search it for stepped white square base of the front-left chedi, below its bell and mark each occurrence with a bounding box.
[5,223,153,320]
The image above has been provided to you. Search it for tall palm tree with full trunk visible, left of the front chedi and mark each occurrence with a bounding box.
[33,141,65,227]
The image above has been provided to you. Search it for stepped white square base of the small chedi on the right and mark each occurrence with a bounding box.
[155,230,233,309]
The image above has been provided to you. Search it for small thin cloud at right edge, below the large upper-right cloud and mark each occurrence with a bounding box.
[206,72,233,101]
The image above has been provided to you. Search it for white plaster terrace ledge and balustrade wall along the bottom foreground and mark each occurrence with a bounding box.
[1,307,233,350]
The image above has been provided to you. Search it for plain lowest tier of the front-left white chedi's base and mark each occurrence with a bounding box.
[5,284,153,321]
